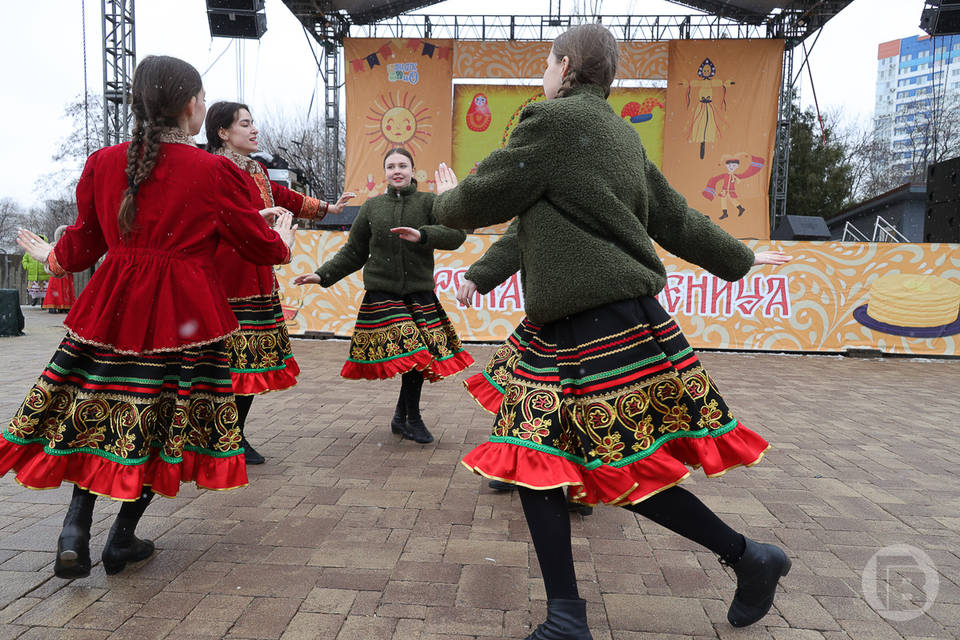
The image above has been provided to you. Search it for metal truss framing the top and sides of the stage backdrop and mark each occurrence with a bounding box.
[284,0,851,231]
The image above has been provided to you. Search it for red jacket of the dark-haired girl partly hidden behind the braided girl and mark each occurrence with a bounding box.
[216,160,326,300]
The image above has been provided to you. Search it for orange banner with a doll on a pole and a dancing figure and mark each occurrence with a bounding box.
[663,40,783,238]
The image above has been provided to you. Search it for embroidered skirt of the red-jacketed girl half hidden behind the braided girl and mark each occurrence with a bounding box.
[226,291,300,396]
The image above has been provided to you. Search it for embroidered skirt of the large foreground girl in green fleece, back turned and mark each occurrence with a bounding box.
[463,298,769,505]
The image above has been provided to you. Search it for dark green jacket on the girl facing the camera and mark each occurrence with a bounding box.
[316,182,467,295]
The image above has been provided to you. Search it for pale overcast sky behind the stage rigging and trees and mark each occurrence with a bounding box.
[0,0,924,205]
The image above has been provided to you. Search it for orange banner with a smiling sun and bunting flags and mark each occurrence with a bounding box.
[343,38,453,205]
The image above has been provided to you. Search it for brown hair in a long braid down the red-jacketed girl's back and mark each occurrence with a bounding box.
[117,56,203,234]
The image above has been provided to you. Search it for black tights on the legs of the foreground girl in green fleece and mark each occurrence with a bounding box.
[519,486,746,600]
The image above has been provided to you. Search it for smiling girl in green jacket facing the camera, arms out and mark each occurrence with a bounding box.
[293,148,473,444]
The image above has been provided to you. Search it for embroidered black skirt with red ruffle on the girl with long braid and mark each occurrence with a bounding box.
[0,335,247,500]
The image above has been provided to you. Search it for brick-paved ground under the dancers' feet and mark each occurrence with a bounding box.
[0,308,960,640]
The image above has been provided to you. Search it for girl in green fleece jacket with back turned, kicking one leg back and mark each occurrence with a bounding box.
[434,24,790,640]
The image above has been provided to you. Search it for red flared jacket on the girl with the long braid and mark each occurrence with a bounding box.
[49,143,290,353]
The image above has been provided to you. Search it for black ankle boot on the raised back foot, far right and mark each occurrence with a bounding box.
[727,537,792,627]
